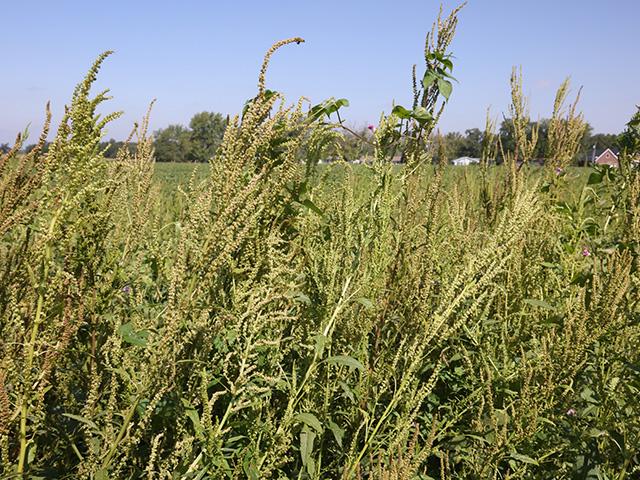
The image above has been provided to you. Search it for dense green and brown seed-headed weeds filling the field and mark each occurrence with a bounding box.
[0,4,640,480]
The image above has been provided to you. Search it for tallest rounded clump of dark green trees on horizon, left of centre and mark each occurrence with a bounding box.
[154,112,227,162]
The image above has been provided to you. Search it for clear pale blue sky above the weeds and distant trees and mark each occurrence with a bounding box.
[0,0,640,142]
